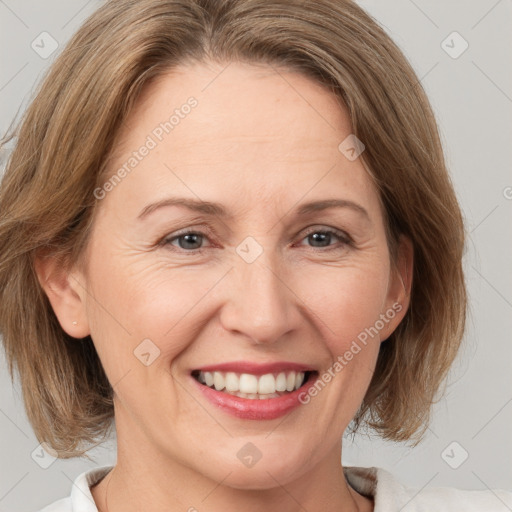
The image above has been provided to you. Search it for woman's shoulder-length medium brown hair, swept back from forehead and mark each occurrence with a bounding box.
[0,0,466,457]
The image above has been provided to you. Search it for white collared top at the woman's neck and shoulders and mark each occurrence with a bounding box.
[39,466,512,512]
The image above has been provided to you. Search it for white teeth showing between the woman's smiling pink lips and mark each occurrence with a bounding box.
[192,370,317,400]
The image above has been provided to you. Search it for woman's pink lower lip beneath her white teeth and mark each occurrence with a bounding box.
[190,375,316,420]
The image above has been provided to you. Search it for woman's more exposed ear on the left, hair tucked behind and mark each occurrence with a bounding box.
[34,255,90,338]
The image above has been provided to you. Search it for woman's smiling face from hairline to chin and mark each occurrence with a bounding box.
[68,63,407,489]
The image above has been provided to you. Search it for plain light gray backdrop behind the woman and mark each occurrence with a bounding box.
[0,0,512,512]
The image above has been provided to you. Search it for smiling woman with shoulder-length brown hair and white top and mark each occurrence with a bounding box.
[0,0,512,512]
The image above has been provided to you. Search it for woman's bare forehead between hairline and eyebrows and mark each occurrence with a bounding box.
[101,63,375,220]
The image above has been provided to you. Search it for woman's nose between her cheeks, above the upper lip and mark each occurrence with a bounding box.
[220,251,301,344]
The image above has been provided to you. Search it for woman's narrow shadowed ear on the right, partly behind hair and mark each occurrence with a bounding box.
[380,235,414,341]
